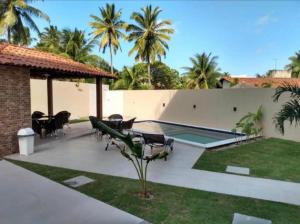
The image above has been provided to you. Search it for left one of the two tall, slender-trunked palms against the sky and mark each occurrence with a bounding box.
[90,4,126,74]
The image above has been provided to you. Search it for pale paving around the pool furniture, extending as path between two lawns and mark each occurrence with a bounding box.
[8,122,300,205]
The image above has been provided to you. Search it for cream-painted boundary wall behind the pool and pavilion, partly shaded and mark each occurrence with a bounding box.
[31,80,300,141]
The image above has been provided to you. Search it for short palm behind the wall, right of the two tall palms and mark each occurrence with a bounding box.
[184,53,220,89]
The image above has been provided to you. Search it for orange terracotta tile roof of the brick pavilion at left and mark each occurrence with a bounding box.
[0,43,114,78]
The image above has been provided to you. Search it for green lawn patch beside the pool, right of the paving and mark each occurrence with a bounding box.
[194,138,300,182]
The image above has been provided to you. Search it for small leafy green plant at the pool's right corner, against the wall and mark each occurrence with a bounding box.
[232,105,263,138]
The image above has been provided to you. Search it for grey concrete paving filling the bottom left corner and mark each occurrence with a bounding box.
[0,160,143,224]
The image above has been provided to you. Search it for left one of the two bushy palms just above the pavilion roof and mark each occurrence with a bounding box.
[36,26,62,53]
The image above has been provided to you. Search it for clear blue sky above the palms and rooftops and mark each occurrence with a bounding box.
[32,0,300,76]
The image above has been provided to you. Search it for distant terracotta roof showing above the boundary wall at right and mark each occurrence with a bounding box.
[221,77,300,87]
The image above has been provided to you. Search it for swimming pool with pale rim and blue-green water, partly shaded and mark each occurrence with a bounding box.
[133,120,246,149]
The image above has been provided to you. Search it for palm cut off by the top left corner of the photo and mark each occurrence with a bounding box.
[0,0,50,43]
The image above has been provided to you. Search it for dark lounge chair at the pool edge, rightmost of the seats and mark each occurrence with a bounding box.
[142,133,174,160]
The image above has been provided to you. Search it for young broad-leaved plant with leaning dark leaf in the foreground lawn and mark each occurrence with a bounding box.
[97,121,168,198]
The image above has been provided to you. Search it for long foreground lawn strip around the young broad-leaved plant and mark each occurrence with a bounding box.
[8,161,300,224]
